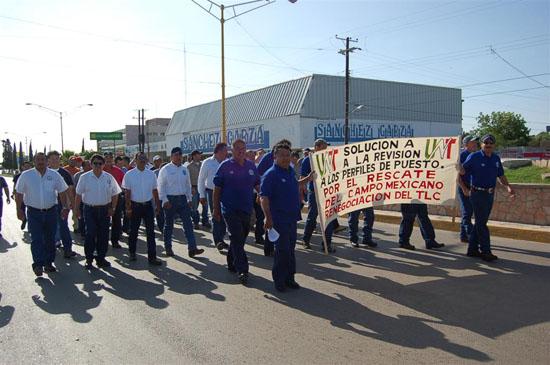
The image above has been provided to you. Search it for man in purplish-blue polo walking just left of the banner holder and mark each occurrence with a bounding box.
[212,139,260,284]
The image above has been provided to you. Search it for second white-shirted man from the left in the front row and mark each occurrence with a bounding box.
[73,154,122,270]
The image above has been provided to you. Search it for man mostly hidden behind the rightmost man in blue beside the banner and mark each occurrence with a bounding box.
[457,136,478,243]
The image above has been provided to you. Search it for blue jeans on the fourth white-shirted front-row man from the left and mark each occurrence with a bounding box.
[163,195,197,250]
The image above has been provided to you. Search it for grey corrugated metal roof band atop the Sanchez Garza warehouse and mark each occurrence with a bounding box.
[166,74,462,135]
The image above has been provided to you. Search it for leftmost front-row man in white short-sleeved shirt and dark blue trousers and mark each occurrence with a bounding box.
[15,152,69,276]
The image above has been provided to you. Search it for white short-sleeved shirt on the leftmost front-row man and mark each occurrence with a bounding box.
[15,168,68,209]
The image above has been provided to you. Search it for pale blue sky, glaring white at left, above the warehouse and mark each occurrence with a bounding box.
[0,0,550,155]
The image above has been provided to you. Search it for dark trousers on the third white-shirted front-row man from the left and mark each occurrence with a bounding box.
[128,202,157,260]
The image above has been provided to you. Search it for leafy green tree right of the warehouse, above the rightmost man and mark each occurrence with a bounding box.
[471,112,531,147]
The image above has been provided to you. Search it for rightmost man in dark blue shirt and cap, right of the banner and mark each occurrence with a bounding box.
[460,134,516,261]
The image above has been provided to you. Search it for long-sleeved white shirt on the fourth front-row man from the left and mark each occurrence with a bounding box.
[157,162,193,204]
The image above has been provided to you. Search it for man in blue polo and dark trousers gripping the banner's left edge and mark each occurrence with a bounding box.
[260,145,308,292]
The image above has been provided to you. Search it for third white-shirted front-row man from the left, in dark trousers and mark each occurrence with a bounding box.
[122,152,162,266]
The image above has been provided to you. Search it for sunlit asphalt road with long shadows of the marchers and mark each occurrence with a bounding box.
[0,205,550,364]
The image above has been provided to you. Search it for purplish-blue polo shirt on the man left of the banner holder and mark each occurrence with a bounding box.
[214,157,260,214]
